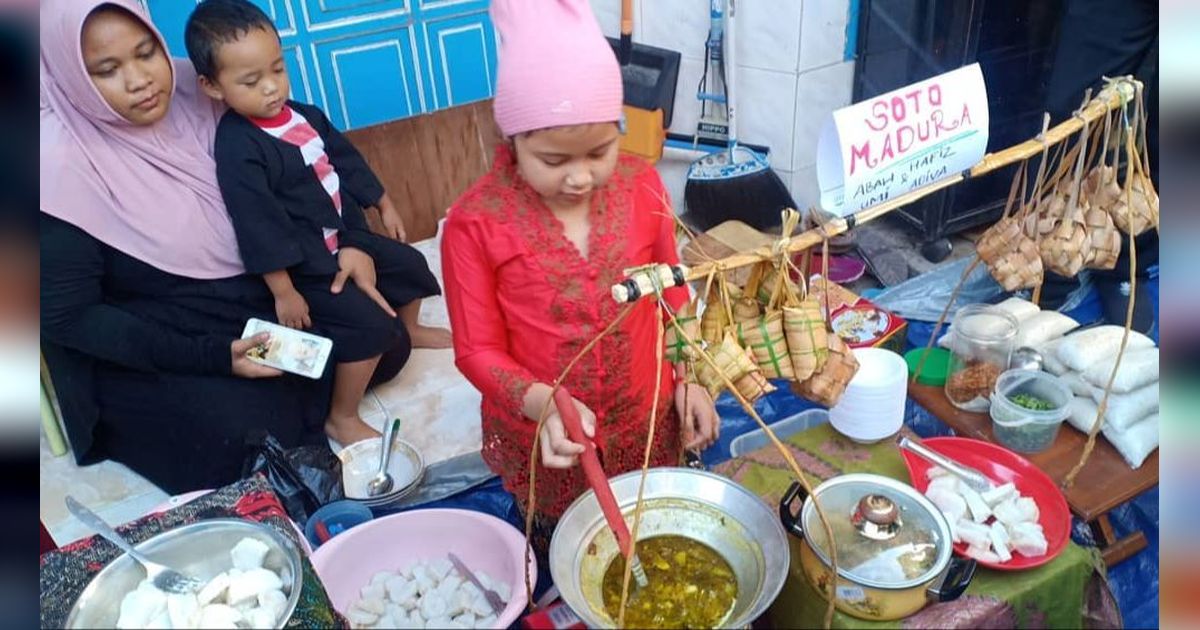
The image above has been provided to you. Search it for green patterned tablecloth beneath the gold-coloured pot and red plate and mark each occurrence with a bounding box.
[714,425,1121,629]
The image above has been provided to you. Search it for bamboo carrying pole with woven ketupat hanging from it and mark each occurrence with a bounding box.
[633,77,1141,290]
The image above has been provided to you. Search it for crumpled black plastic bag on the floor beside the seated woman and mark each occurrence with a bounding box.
[241,431,344,524]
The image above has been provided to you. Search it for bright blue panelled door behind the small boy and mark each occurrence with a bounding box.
[142,0,496,130]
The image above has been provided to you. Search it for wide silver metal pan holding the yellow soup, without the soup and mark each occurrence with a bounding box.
[550,468,790,628]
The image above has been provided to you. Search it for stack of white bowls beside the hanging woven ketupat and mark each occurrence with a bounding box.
[829,348,908,444]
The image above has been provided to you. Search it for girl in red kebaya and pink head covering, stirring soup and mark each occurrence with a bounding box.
[442,0,719,542]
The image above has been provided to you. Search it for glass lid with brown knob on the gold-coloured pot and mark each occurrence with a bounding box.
[800,474,950,588]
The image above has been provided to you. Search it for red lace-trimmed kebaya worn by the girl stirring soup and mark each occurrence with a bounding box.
[442,145,688,518]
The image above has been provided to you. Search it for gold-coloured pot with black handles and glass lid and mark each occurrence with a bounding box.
[779,473,976,620]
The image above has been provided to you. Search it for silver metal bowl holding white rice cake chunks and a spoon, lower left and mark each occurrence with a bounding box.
[66,518,304,628]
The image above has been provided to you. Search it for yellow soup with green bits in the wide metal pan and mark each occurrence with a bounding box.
[602,536,738,628]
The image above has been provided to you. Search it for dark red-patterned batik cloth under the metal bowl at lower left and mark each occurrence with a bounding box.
[41,475,349,628]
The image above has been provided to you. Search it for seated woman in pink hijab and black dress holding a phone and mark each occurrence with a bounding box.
[40,0,410,493]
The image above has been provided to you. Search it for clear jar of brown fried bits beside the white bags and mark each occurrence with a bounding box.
[946,304,1020,412]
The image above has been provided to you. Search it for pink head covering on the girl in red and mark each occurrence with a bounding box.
[491,0,624,137]
